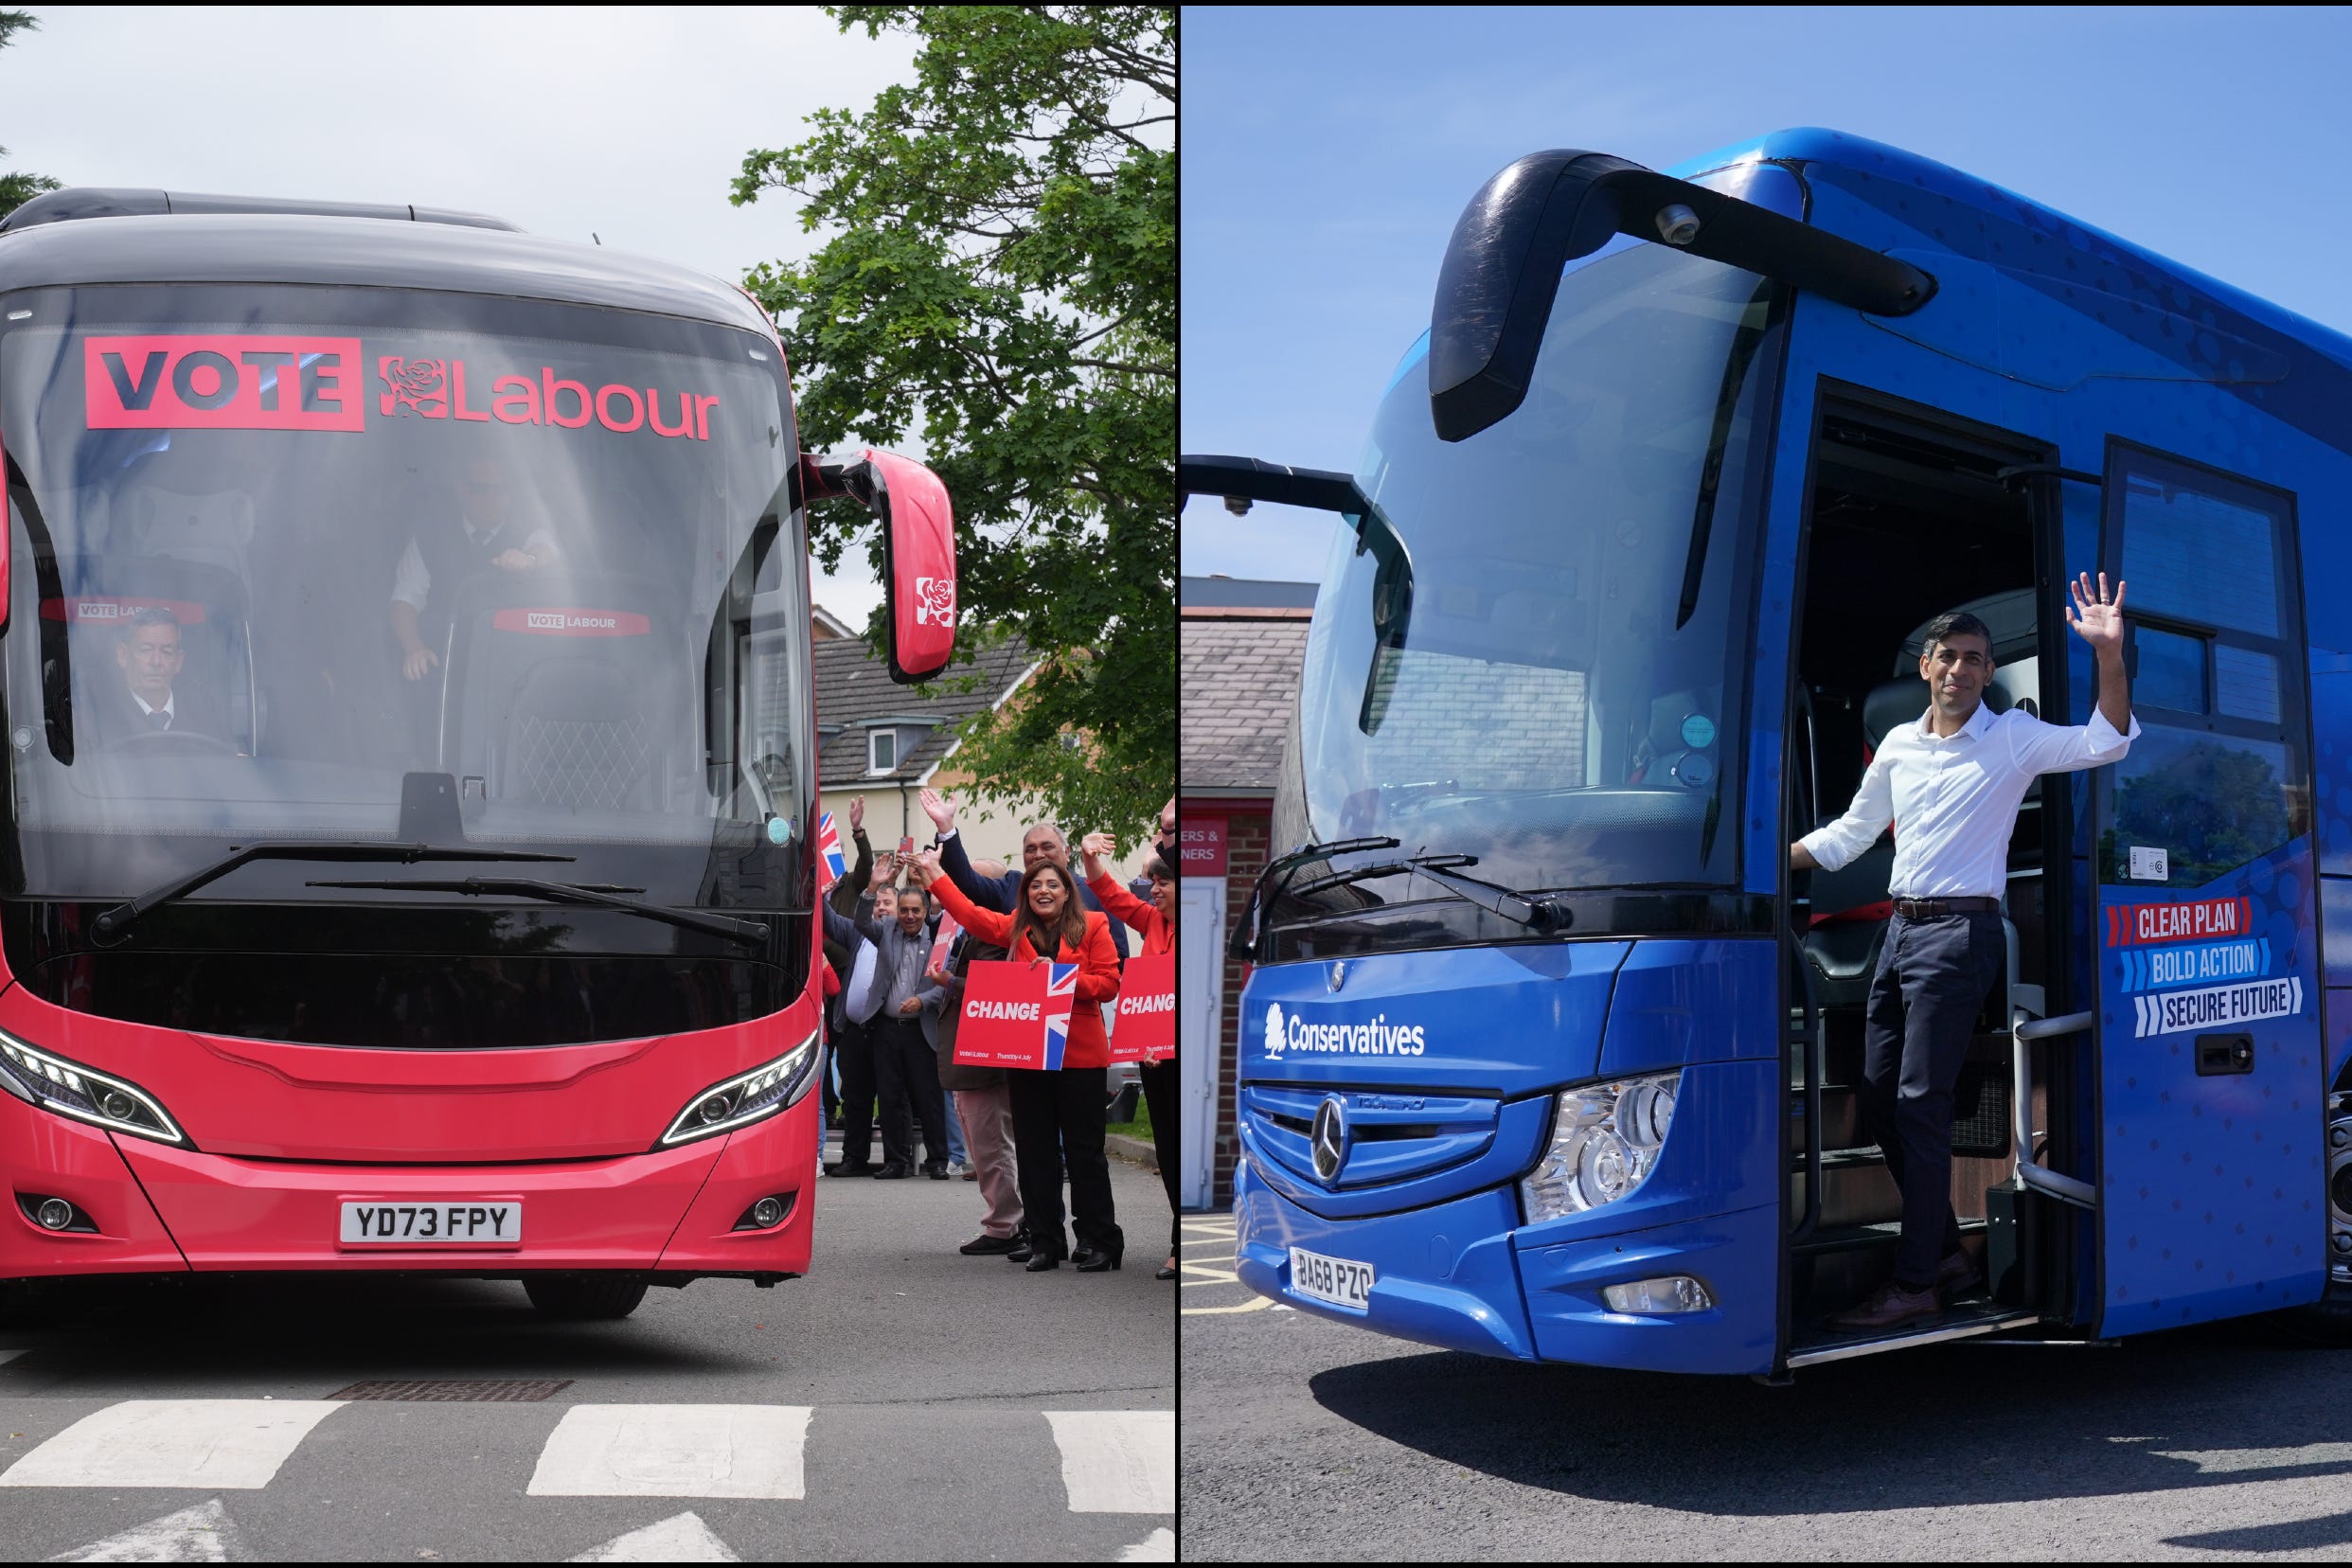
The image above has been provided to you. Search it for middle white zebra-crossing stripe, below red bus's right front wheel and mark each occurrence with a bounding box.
[529,1406,811,1498]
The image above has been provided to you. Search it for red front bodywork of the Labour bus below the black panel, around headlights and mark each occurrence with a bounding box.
[0,934,823,1279]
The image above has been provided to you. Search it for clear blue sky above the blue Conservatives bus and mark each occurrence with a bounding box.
[1181,7,2352,579]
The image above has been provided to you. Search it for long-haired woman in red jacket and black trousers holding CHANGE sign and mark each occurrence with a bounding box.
[915,848,1127,1274]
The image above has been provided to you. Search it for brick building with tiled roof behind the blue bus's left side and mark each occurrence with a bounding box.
[1178,576,1315,1208]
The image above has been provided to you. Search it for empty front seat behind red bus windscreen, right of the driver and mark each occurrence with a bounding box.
[442,571,694,811]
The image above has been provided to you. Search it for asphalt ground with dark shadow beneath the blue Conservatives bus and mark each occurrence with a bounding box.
[1178,1216,2352,1561]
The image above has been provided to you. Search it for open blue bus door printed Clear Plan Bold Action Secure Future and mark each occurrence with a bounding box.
[2086,439,2326,1335]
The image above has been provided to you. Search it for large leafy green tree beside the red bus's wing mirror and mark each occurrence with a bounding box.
[734,5,1176,844]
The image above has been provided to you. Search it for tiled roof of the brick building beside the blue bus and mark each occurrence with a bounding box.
[1181,615,1308,790]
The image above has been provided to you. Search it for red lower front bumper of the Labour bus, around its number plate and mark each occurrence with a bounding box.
[0,1093,821,1279]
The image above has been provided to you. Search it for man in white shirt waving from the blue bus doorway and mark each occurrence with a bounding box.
[1788,571,2140,1328]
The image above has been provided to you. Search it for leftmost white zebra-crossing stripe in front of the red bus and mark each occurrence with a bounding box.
[0,1399,344,1490]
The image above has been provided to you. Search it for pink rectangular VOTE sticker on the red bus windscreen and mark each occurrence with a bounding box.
[82,334,367,430]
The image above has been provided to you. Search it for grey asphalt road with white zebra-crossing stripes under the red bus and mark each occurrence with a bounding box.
[0,1161,1176,1561]
